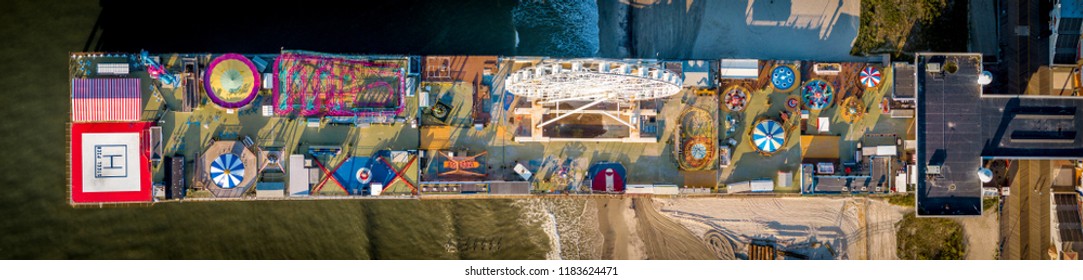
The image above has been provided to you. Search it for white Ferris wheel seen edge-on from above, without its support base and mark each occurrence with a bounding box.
[505,59,681,103]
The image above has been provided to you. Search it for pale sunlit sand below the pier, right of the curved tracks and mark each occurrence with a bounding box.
[654,197,909,259]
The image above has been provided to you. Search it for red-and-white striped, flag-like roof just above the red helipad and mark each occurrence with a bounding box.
[71,78,143,122]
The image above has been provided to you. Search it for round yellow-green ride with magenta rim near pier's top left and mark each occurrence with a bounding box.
[204,53,260,109]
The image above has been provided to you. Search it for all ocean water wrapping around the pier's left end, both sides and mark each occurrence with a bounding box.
[0,0,598,259]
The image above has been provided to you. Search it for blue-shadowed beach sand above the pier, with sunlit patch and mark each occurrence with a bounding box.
[598,0,861,61]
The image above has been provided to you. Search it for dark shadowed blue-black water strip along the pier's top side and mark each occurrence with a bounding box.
[94,0,598,56]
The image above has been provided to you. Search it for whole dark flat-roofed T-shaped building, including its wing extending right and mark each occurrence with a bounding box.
[915,53,1083,216]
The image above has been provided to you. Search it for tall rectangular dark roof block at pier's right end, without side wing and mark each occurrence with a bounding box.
[916,54,982,215]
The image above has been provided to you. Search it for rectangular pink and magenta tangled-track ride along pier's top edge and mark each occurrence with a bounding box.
[274,52,408,117]
